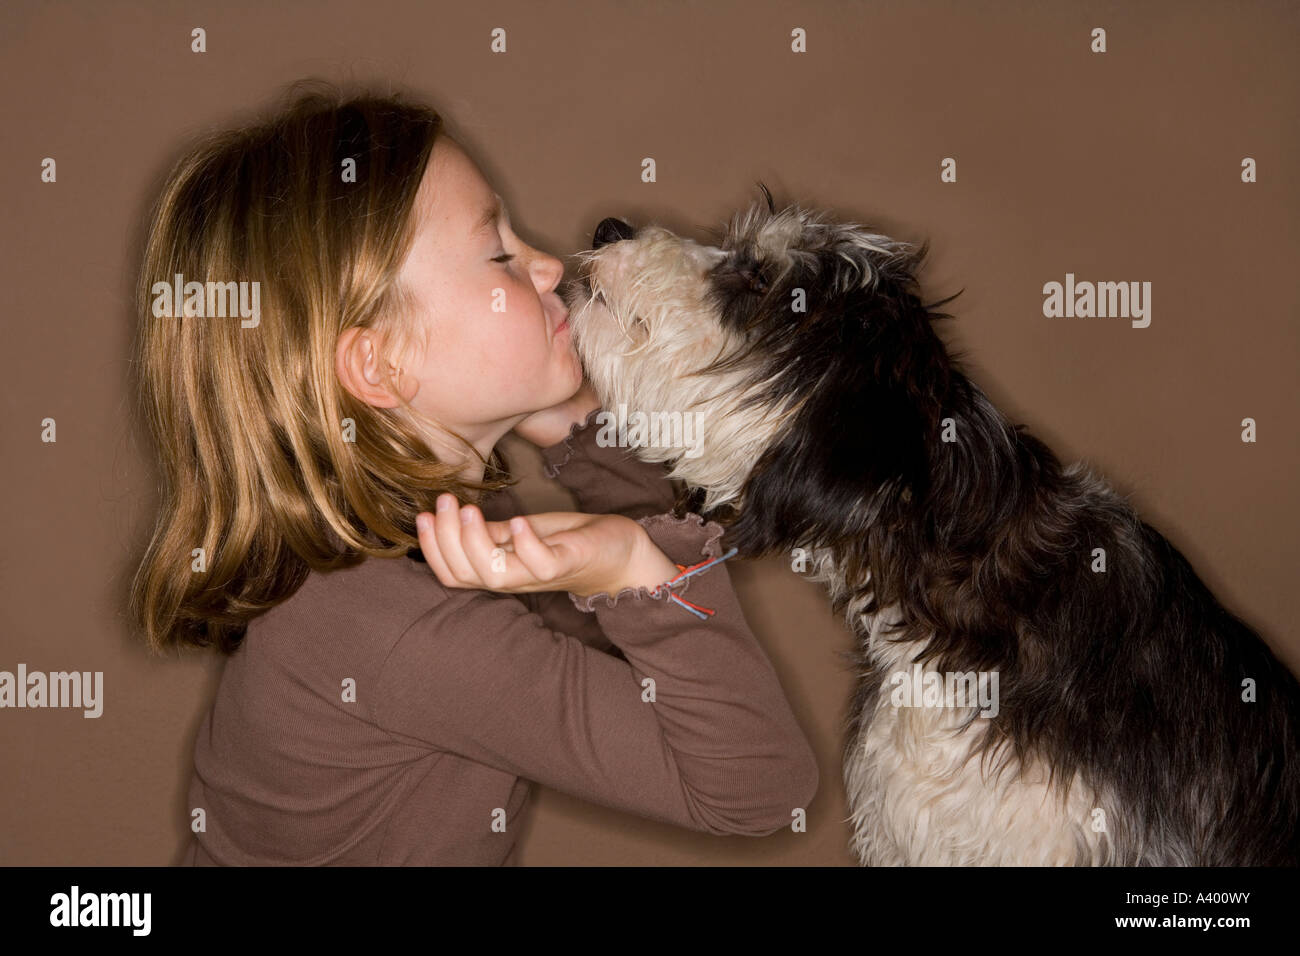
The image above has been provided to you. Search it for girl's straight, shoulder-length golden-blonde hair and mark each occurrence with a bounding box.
[131,83,512,653]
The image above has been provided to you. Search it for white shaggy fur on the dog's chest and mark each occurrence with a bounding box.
[814,550,1109,866]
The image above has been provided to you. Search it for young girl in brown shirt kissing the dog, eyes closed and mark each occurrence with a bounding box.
[133,83,818,865]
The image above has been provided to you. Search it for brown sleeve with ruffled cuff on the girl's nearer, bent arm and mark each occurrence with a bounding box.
[372,514,818,835]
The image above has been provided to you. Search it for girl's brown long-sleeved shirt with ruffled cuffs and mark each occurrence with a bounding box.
[185,412,818,865]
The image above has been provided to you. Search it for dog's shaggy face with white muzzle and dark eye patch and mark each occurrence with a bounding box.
[566,204,907,511]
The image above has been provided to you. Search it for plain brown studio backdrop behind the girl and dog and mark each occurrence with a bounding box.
[0,0,1300,865]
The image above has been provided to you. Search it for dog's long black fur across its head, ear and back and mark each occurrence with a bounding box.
[712,197,1300,866]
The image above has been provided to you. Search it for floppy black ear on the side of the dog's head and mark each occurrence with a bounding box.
[725,254,949,557]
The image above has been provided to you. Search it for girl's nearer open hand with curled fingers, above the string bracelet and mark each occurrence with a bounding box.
[416,494,677,597]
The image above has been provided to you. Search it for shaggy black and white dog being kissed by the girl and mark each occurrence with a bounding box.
[566,187,1300,865]
